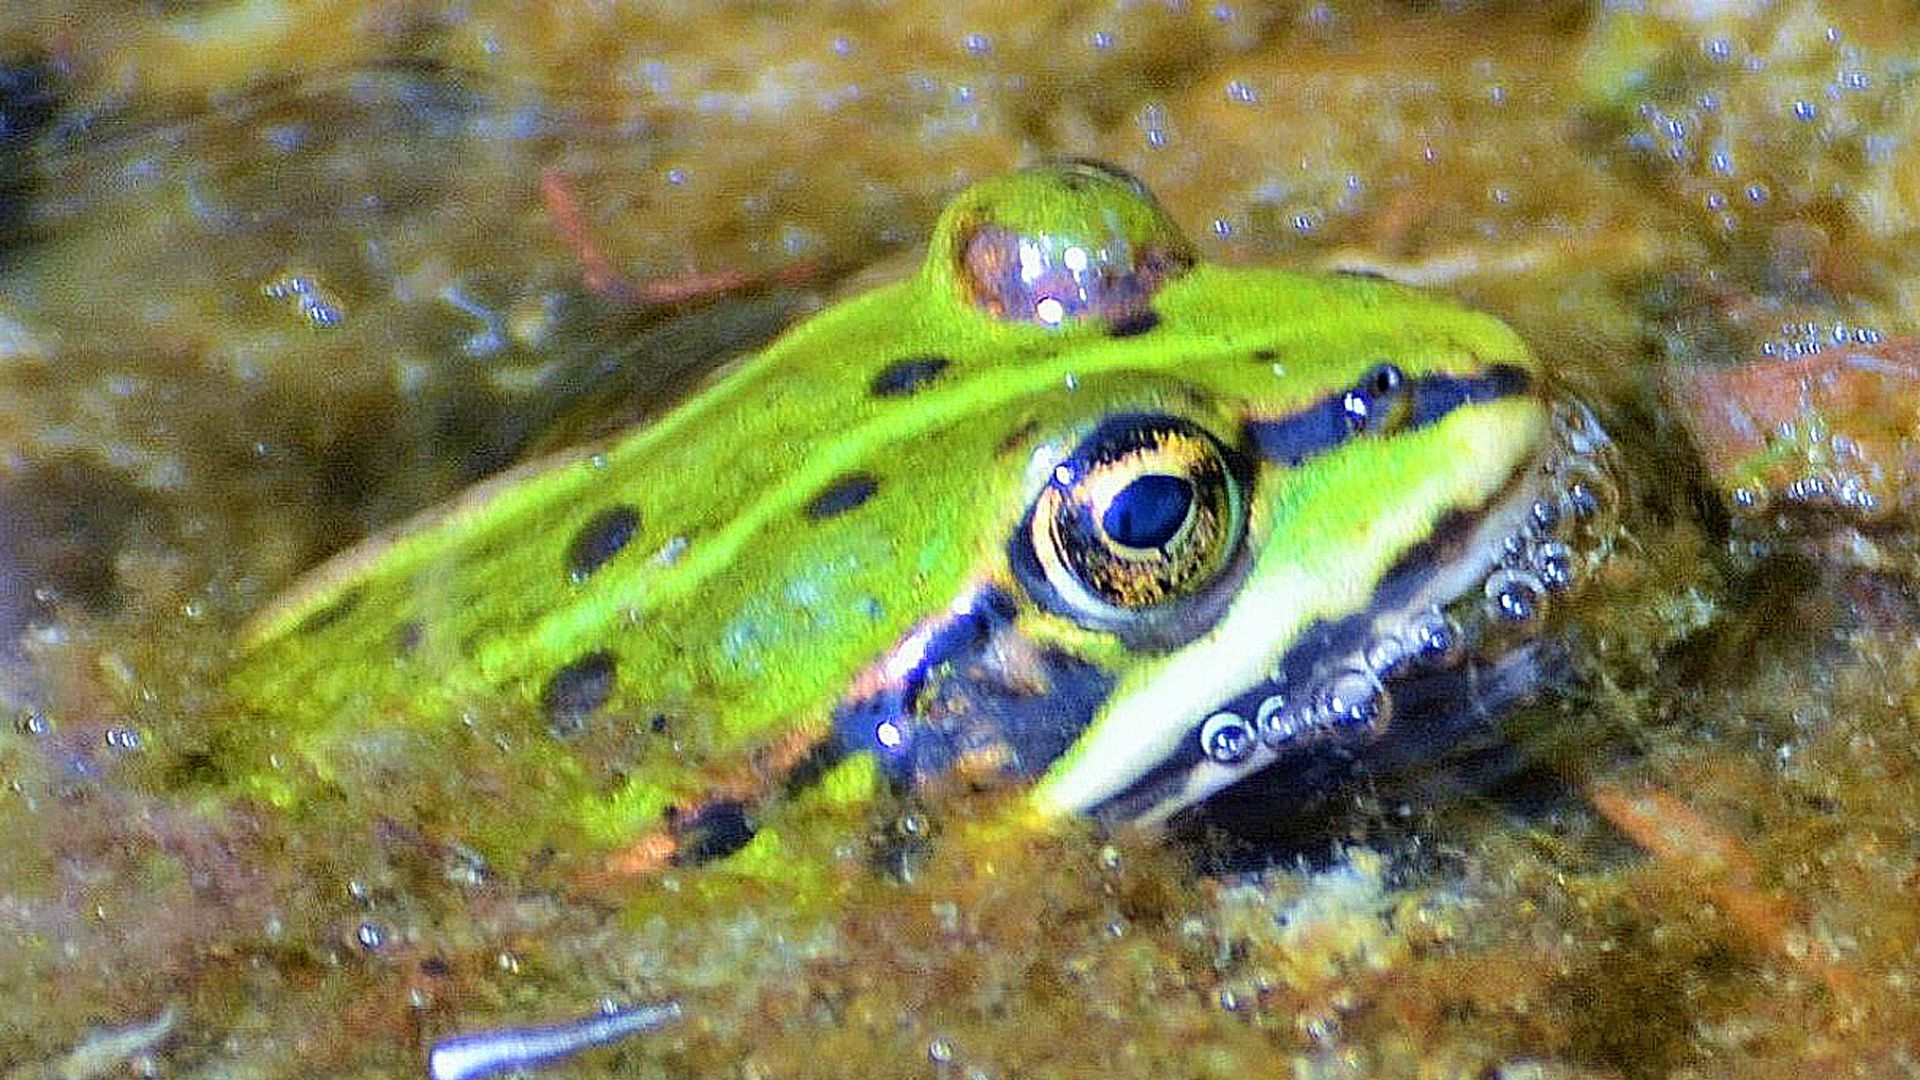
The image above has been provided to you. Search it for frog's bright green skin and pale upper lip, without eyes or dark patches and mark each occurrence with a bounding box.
[232,165,1548,865]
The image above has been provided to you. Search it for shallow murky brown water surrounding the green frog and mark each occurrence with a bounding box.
[0,0,1920,1080]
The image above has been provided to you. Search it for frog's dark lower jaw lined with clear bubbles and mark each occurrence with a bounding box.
[1087,404,1619,824]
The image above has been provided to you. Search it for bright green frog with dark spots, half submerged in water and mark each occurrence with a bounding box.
[232,161,1615,874]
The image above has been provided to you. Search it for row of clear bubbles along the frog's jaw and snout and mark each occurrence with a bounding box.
[1200,405,1620,765]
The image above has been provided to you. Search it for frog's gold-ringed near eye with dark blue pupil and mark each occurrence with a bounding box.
[1016,415,1246,628]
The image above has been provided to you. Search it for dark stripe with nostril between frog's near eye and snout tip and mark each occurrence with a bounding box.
[1246,363,1532,465]
